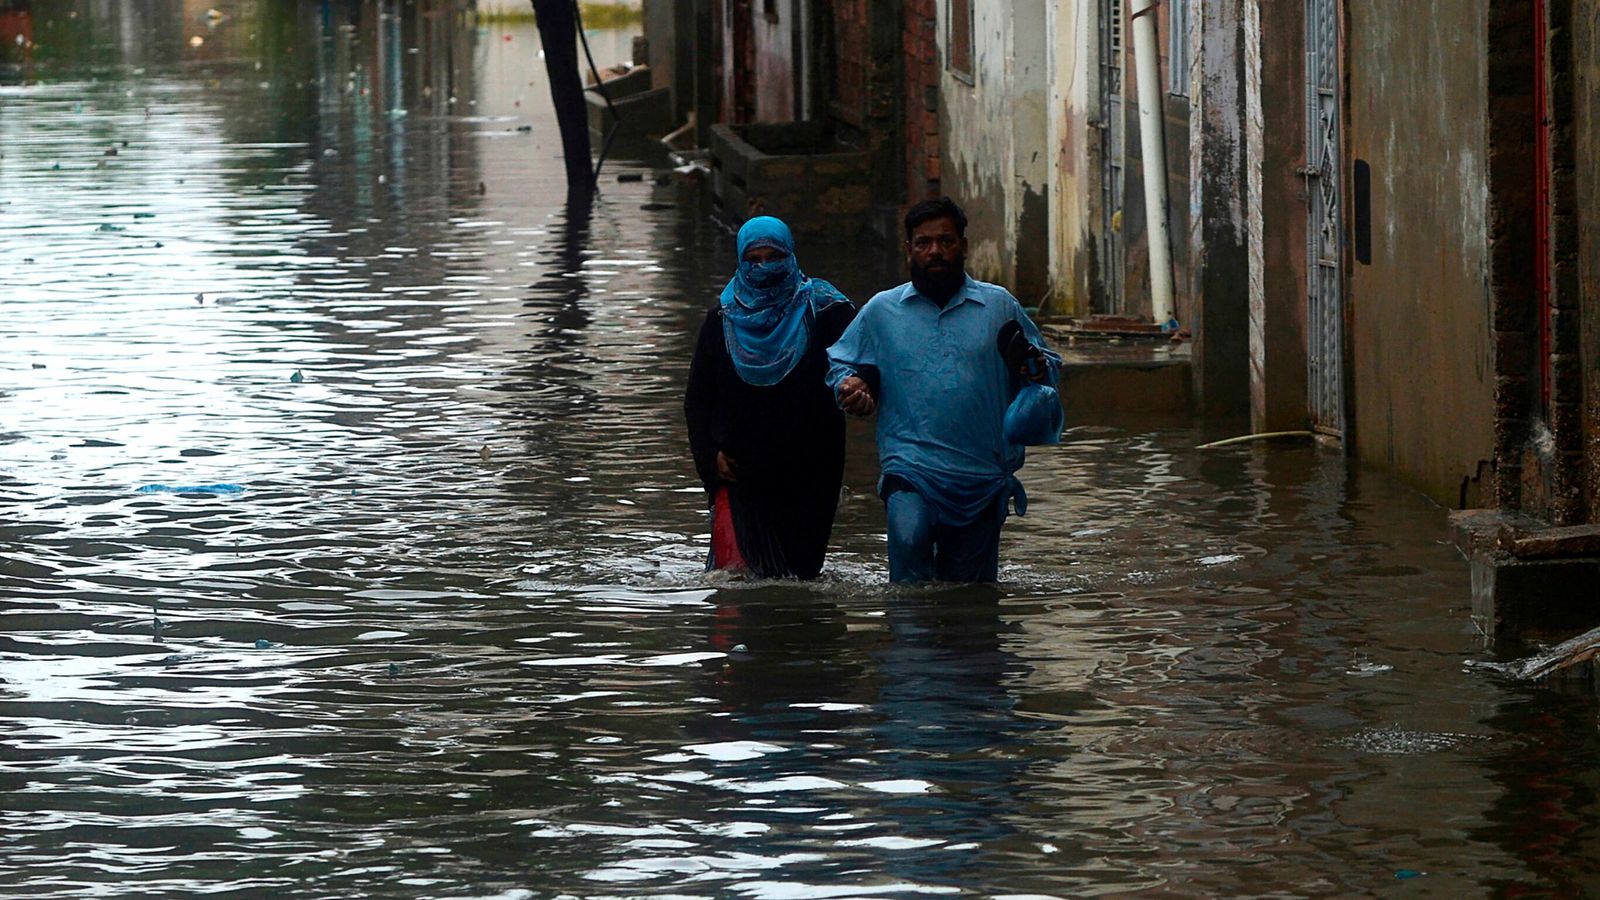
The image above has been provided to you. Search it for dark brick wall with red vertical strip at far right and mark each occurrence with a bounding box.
[1490,0,1594,525]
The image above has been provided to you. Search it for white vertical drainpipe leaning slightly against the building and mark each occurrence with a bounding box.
[1130,0,1176,325]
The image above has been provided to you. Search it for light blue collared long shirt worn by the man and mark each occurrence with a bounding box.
[827,277,1061,525]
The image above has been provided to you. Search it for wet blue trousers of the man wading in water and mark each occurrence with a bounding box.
[885,490,1005,583]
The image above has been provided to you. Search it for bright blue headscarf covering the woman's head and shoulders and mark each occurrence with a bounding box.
[722,216,845,388]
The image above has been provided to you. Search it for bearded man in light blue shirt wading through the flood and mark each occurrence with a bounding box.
[827,197,1061,581]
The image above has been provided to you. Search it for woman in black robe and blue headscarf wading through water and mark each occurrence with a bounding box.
[683,216,856,578]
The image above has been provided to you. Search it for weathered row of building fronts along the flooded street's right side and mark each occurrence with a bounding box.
[646,0,1600,630]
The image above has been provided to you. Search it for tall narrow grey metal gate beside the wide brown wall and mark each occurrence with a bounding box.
[1301,0,1344,437]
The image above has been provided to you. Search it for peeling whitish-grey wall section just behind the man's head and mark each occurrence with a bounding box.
[939,0,1053,306]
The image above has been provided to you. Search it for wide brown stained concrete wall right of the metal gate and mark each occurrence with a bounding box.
[1346,0,1494,506]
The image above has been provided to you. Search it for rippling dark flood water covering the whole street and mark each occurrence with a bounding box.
[0,0,1600,900]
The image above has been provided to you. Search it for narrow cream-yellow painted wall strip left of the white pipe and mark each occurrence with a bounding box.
[1046,0,1101,315]
